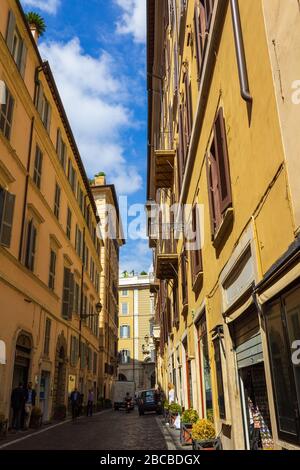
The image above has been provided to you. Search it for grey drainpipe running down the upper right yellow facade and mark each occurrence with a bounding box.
[230,0,253,103]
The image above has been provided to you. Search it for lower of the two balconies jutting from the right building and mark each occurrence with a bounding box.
[155,238,178,280]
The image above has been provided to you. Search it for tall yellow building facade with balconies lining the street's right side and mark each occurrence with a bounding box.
[147,0,300,449]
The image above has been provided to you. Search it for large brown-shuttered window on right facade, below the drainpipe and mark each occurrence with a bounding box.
[207,108,232,239]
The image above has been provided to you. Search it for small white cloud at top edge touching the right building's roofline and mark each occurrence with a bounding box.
[115,0,146,43]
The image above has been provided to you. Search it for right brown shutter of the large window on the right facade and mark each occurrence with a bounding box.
[214,108,232,214]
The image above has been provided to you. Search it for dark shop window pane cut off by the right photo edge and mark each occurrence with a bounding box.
[285,287,300,408]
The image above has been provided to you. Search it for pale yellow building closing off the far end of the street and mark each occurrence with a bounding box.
[118,274,156,390]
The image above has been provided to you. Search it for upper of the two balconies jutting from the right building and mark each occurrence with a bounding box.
[154,150,175,191]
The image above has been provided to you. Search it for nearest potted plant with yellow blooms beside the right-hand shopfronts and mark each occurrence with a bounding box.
[192,419,220,450]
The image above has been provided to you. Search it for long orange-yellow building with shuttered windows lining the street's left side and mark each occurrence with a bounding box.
[0,0,102,421]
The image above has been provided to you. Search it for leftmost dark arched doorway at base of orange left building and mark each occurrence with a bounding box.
[12,331,32,390]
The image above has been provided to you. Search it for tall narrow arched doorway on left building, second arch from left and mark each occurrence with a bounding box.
[53,333,67,414]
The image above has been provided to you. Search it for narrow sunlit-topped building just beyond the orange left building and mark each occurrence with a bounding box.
[91,175,125,400]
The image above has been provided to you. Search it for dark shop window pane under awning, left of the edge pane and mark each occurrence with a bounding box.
[267,301,297,435]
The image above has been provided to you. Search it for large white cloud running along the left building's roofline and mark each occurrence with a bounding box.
[40,38,142,194]
